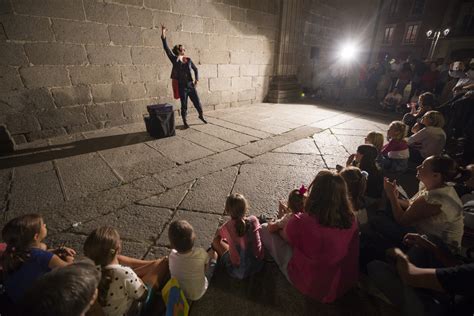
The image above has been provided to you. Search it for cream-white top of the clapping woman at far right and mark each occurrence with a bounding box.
[411,186,464,251]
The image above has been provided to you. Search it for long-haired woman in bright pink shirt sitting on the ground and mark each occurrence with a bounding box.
[262,170,359,303]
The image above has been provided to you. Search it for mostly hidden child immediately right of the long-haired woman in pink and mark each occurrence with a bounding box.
[340,167,369,226]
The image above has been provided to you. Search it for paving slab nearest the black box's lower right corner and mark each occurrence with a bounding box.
[147,136,214,164]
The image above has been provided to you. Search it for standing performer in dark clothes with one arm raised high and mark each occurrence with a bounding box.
[161,24,207,128]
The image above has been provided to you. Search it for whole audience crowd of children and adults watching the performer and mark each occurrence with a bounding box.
[0,60,474,316]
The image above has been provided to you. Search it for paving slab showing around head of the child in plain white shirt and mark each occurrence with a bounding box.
[157,210,222,249]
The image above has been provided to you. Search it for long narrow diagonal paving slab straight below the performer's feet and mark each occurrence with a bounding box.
[158,149,249,188]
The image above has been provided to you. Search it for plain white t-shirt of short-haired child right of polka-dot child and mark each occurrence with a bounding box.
[169,248,209,301]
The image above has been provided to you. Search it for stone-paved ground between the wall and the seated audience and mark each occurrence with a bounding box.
[0,104,398,315]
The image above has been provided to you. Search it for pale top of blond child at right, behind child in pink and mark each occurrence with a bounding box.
[407,126,446,158]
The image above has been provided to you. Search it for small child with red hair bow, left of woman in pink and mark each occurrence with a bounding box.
[268,185,307,241]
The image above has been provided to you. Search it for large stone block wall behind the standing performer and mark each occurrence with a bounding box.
[0,0,280,143]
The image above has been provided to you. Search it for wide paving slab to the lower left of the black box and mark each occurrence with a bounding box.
[100,143,176,182]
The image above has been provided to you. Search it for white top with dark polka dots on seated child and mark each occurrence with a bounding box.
[102,264,146,316]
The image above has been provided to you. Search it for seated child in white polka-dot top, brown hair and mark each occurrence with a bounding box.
[84,226,168,315]
